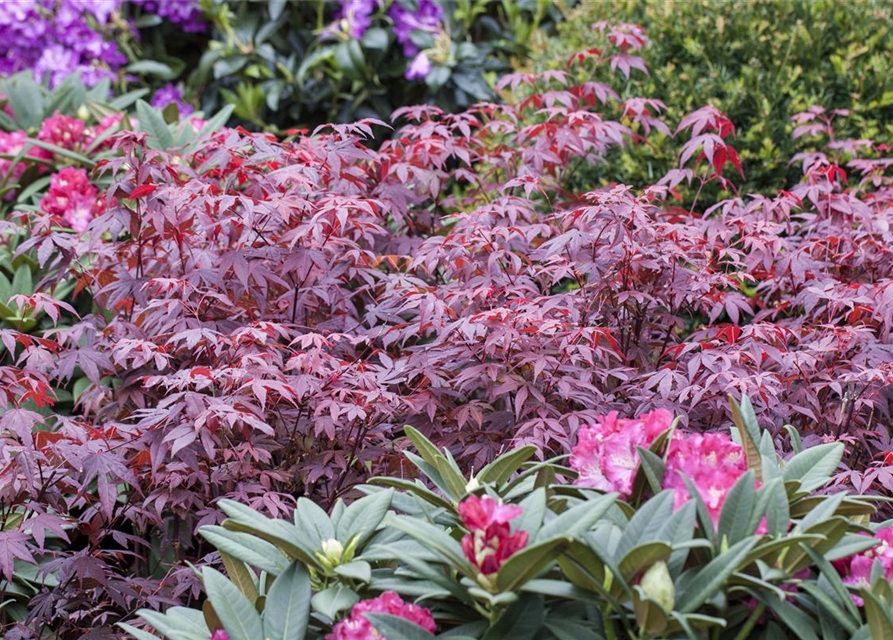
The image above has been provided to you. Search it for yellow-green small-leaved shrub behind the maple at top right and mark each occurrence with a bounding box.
[521,0,893,196]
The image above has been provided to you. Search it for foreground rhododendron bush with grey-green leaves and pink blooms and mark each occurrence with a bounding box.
[122,416,893,640]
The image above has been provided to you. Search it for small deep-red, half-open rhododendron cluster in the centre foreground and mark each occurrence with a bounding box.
[459,496,527,576]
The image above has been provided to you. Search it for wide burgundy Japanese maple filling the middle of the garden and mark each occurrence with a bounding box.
[0,22,893,633]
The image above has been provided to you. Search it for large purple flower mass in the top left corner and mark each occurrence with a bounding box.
[0,0,127,87]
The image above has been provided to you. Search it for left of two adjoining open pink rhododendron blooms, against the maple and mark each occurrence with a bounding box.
[570,409,673,496]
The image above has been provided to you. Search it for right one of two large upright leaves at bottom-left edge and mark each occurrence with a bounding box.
[264,562,311,640]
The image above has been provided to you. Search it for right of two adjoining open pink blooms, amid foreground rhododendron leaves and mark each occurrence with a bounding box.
[664,433,747,522]
